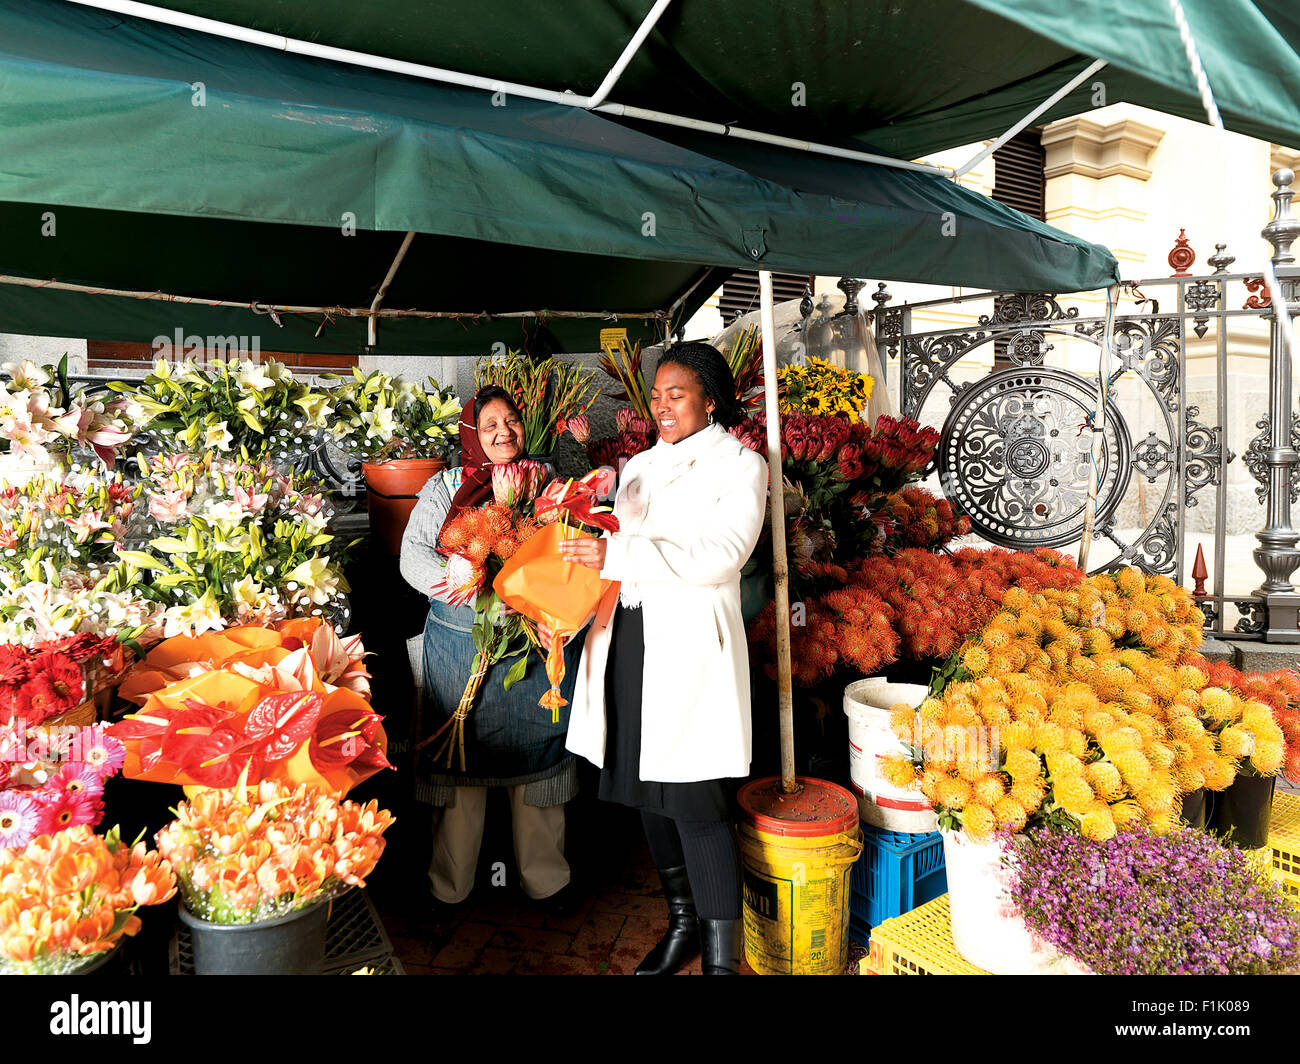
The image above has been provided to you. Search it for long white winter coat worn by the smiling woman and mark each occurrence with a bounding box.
[568,425,767,783]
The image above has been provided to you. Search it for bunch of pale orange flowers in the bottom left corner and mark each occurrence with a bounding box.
[0,822,176,974]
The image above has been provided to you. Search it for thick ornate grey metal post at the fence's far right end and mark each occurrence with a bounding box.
[1253,169,1300,643]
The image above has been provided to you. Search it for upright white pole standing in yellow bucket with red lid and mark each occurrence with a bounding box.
[758,269,797,795]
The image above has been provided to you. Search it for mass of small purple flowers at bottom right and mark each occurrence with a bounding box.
[1011,829,1300,976]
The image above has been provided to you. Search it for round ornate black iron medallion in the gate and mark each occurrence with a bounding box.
[937,368,1132,548]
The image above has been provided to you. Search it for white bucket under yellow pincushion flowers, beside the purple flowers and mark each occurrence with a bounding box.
[943,831,1088,976]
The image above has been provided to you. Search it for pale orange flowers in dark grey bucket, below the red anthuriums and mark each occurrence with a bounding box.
[157,780,393,924]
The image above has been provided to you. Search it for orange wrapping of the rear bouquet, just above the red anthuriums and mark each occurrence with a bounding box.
[117,617,369,705]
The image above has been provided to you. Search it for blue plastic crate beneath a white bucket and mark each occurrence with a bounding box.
[849,825,948,943]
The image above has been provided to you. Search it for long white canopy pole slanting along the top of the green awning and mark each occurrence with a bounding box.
[61,0,953,177]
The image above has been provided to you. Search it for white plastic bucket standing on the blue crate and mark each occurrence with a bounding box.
[844,676,939,832]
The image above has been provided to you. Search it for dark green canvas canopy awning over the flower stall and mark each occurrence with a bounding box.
[0,0,1300,352]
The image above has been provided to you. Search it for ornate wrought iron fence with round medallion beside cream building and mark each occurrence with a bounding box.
[872,172,1300,641]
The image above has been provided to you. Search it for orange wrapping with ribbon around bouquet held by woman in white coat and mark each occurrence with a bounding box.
[493,522,619,718]
